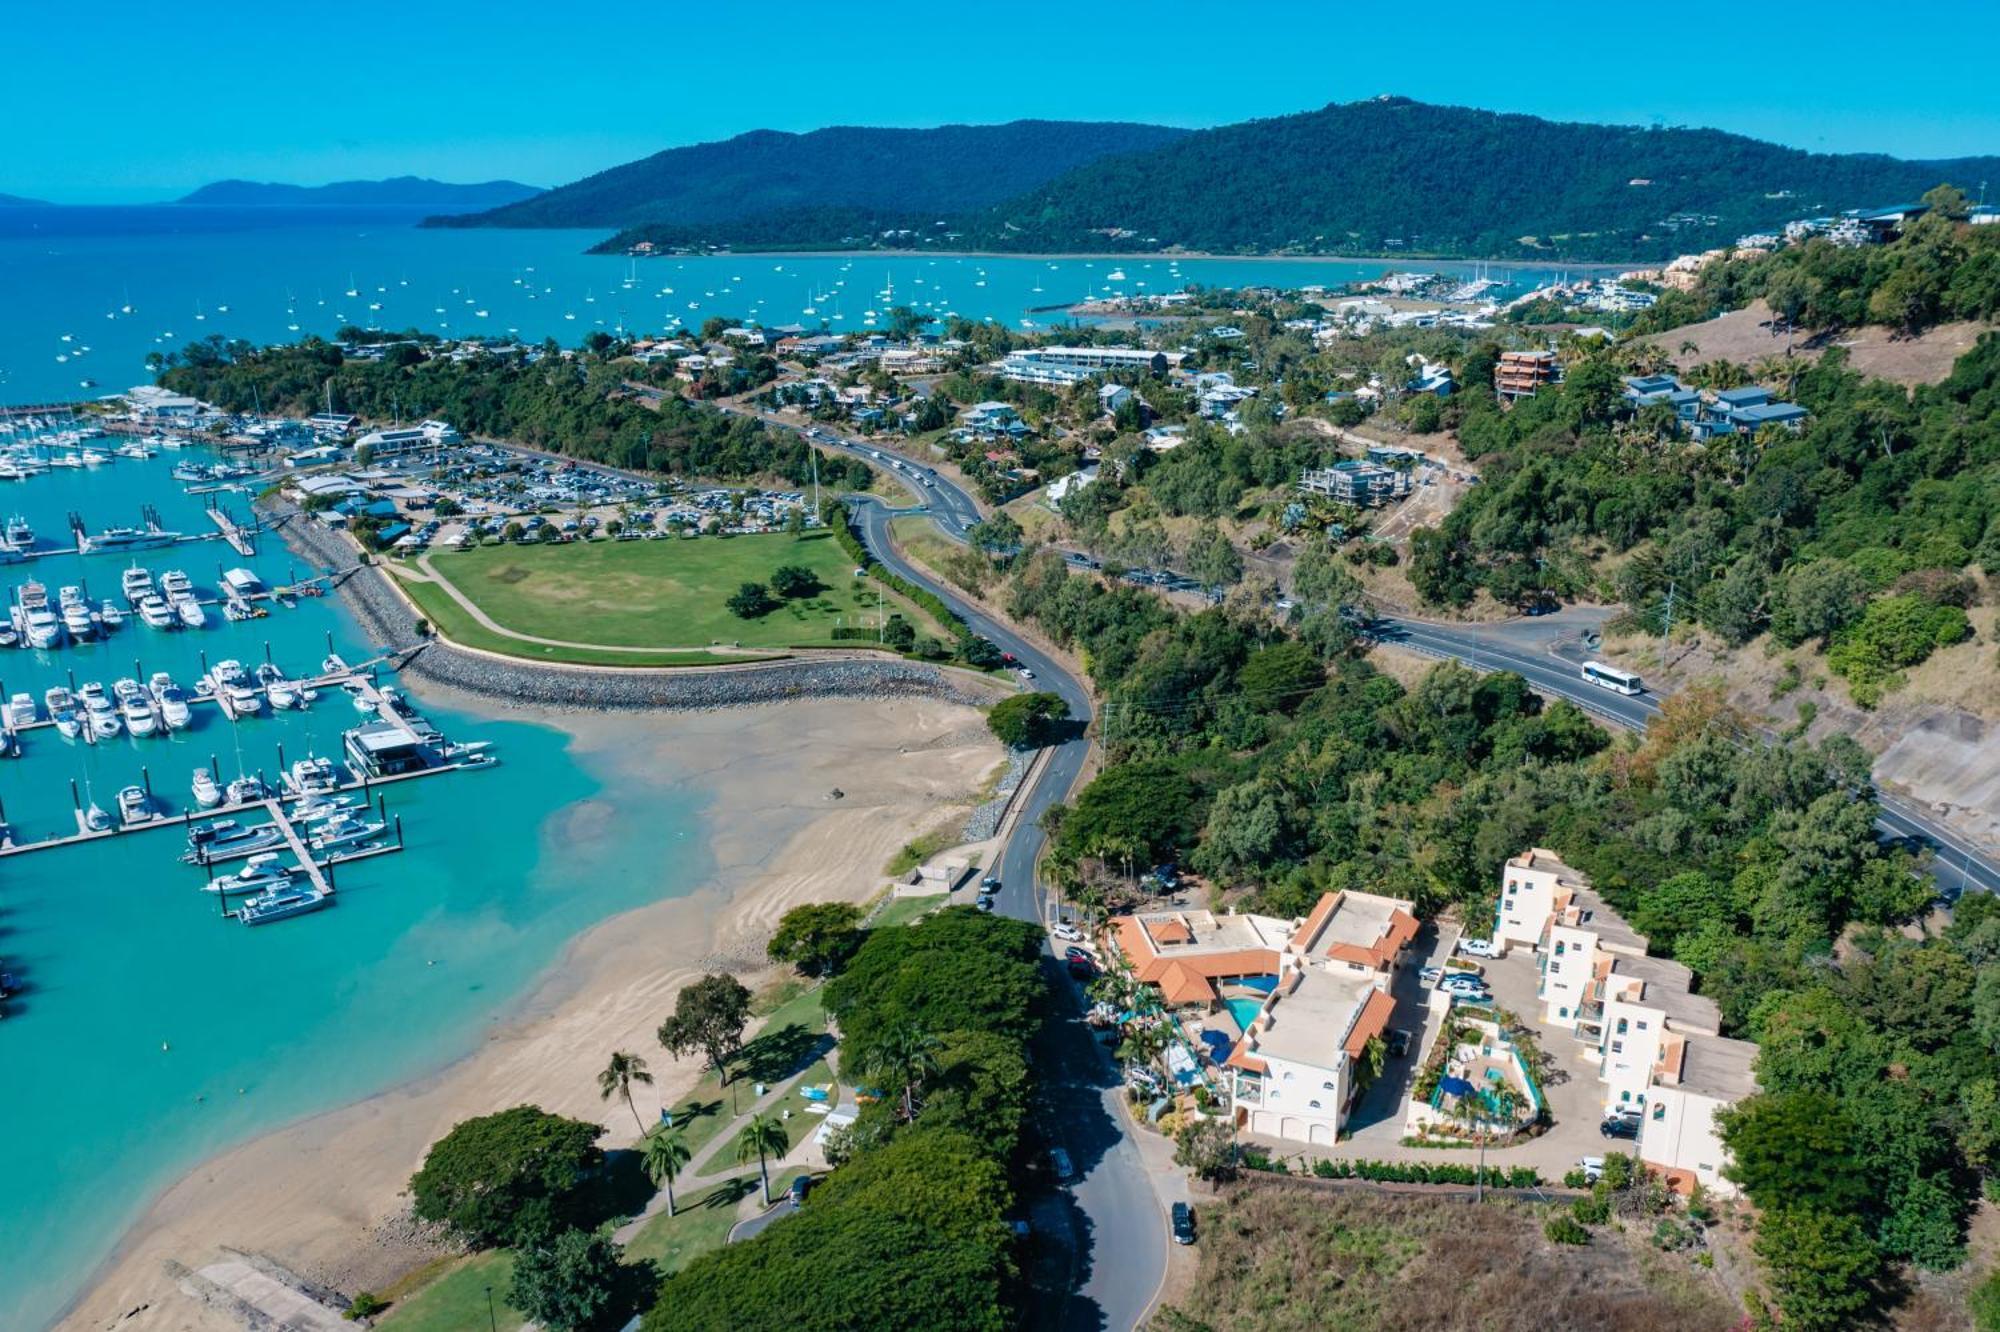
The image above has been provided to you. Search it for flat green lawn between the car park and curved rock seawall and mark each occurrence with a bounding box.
[418,532,942,660]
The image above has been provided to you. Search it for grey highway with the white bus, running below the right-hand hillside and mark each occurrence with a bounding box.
[1376,616,2000,898]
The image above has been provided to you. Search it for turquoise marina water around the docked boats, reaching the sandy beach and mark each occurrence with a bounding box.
[0,450,712,1328]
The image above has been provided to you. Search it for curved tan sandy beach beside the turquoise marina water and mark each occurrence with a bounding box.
[58,690,1002,1332]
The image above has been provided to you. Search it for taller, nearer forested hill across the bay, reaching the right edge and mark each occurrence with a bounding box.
[584,98,2000,260]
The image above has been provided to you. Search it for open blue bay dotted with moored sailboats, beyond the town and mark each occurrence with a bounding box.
[0,208,1556,402]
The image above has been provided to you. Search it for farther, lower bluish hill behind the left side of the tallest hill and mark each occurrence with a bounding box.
[432,120,1184,226]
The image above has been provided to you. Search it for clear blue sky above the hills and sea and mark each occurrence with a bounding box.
[15,0,2000,202]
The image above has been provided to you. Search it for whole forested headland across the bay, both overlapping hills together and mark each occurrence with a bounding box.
[432,98,2000,262]
